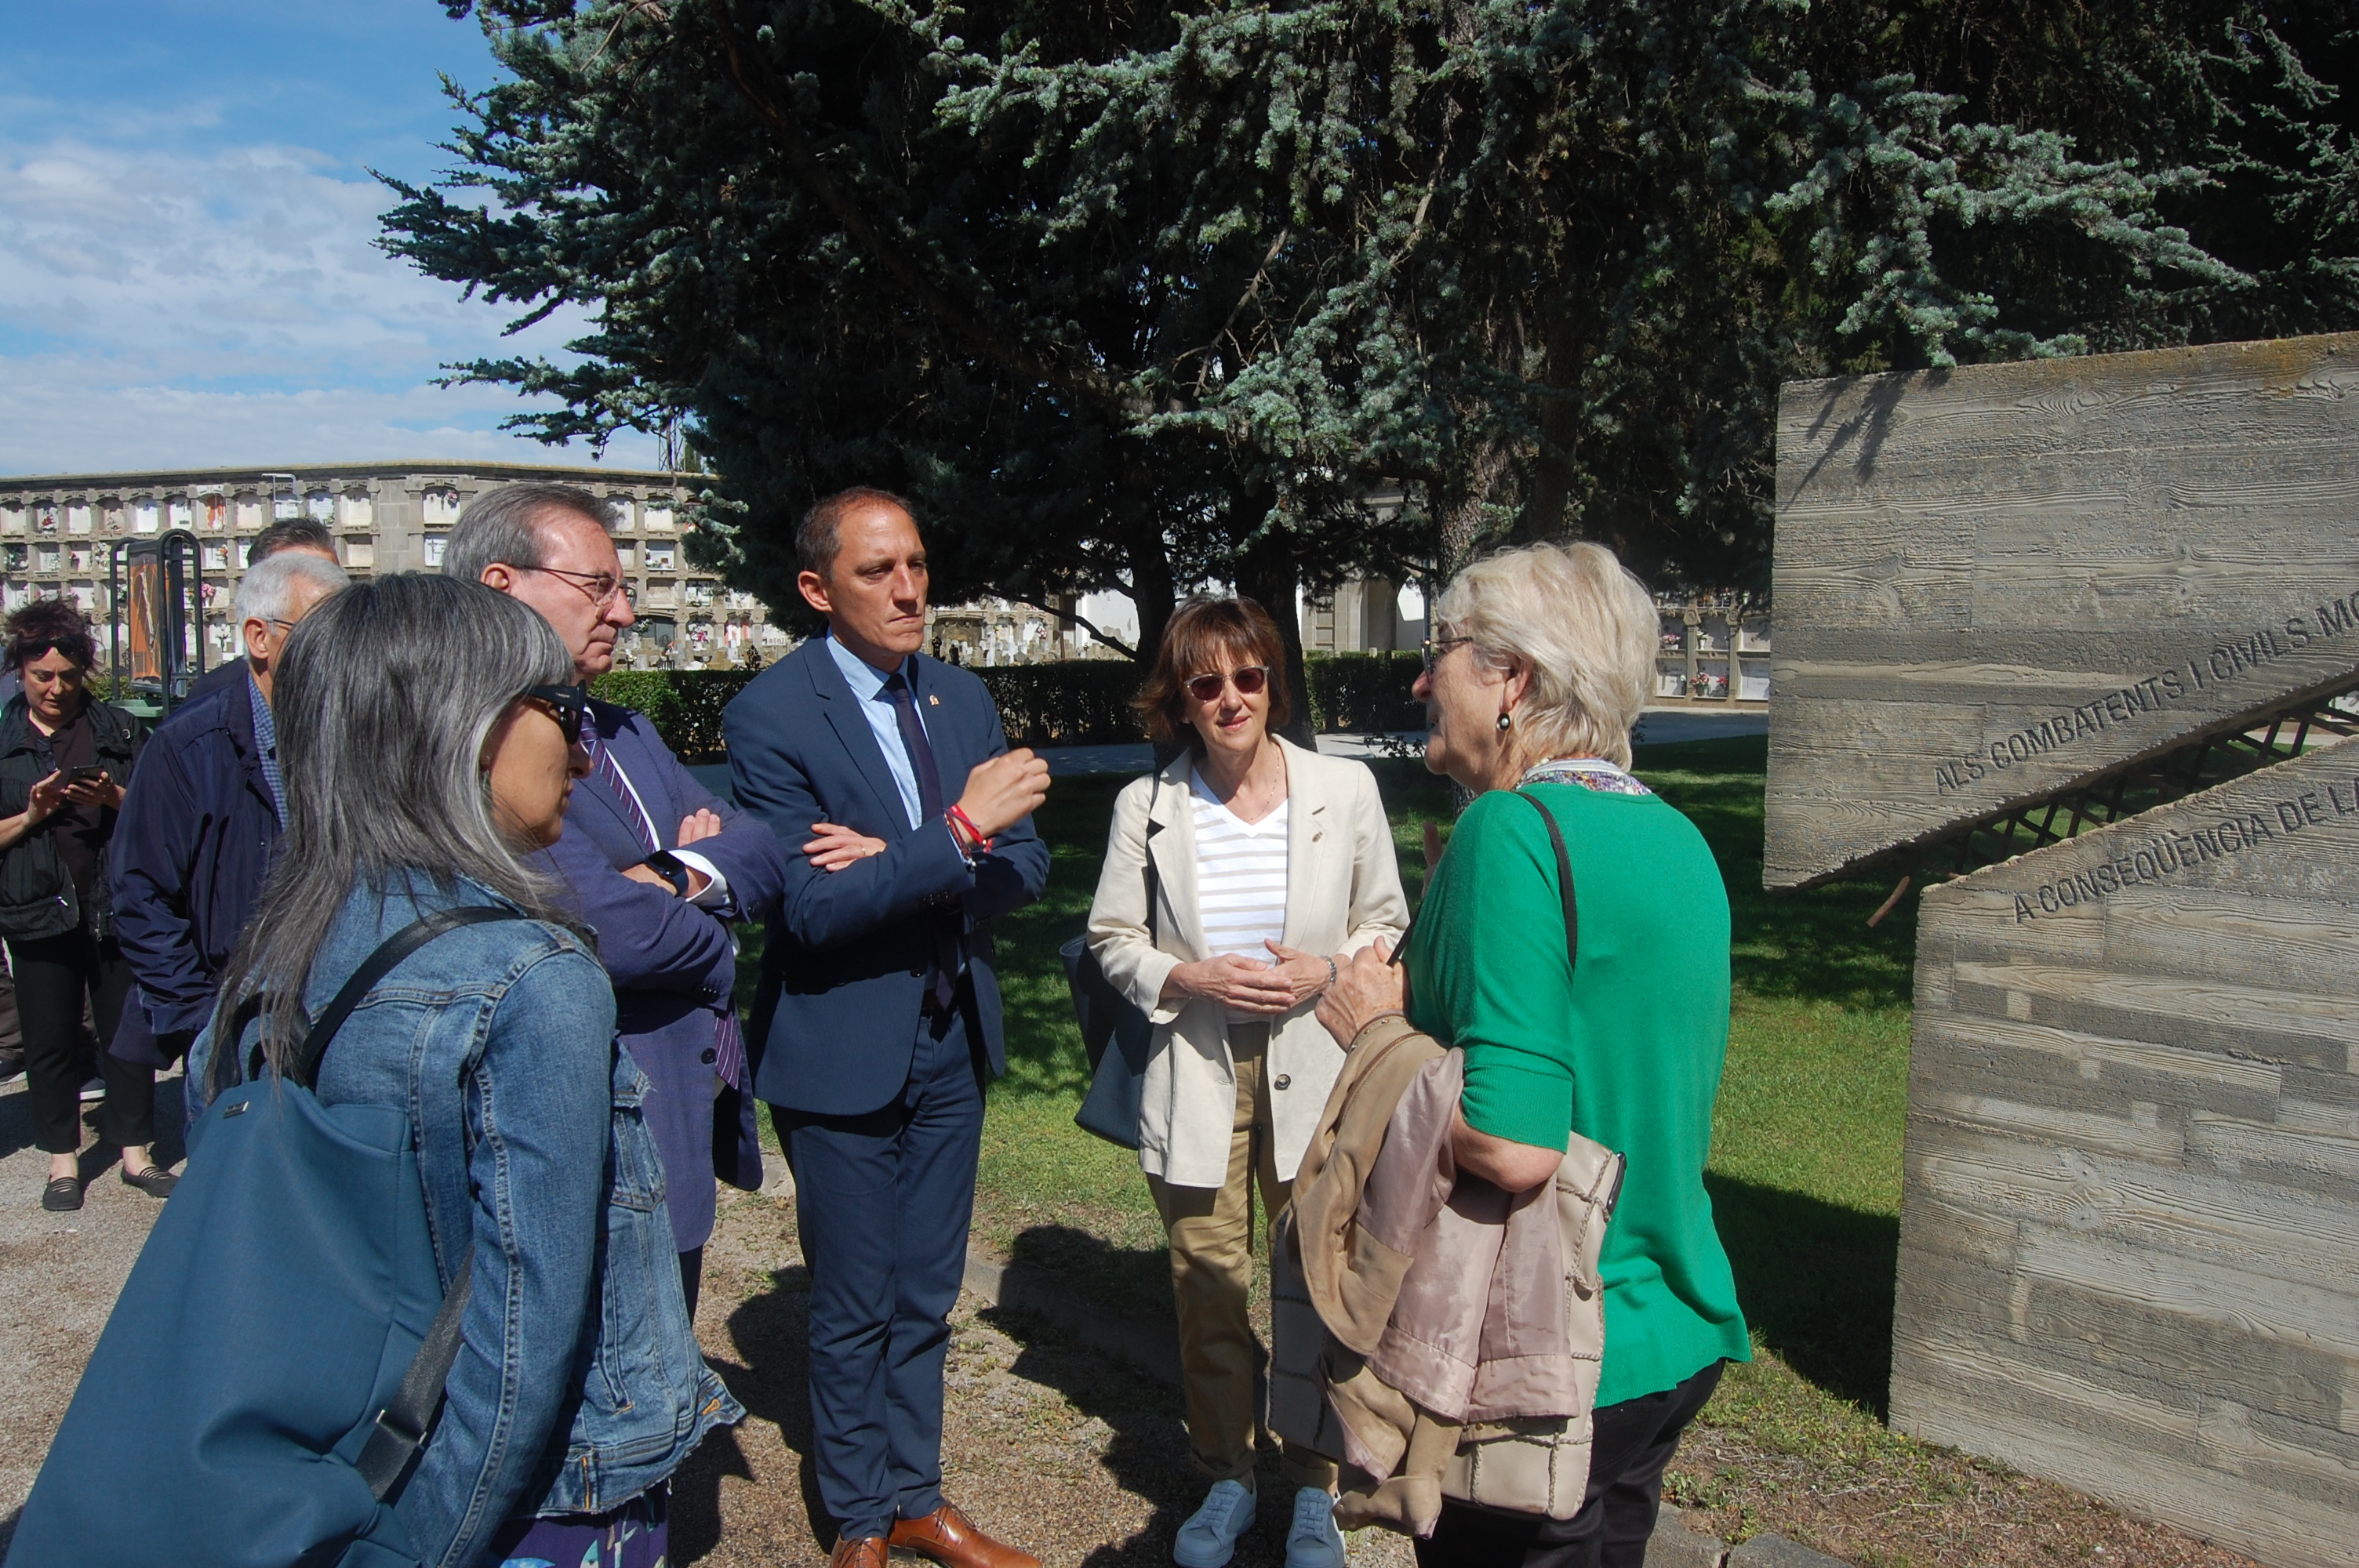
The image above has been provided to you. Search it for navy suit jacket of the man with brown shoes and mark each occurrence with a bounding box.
[722,637,1048,1116]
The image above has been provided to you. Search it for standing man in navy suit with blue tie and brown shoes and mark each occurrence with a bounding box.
[722,491,1048,1568]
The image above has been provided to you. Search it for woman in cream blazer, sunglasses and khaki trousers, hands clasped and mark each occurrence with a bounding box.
[1090,599,1408,1568]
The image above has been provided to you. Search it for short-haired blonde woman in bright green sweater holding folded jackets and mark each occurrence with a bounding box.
[1318,545,1750,1568]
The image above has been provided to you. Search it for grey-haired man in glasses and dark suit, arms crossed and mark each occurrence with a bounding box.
[444,484,786,1318]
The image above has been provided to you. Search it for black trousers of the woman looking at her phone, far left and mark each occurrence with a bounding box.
[7,931,156,1156]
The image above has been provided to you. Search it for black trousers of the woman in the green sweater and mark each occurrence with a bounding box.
[1418,1360,1727,1568]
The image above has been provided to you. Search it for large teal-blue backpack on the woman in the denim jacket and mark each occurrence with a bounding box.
[7,906,524,1568]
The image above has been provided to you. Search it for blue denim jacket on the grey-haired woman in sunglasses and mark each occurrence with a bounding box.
[189,882,746,1568]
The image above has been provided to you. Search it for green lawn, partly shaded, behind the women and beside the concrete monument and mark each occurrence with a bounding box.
[745,738,1915,1453]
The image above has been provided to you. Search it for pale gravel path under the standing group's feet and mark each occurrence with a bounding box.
[0,1077,1413,1568]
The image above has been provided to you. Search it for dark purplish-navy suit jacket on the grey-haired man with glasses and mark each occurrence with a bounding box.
[545,702,786,1252]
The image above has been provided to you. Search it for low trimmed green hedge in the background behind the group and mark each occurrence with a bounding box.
[590,653,1425,761]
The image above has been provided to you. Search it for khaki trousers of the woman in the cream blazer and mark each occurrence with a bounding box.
[1147,1023,1336,1490]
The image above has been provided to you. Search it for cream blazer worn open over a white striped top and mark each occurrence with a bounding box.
[1090,740,1408,1189]
